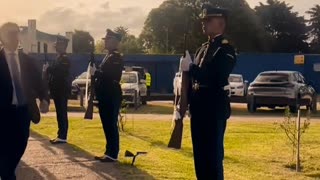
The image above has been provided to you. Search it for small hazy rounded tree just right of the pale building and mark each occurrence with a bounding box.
[72,30,94,53]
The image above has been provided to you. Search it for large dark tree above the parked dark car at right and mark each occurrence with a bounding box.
[255,0,308,53]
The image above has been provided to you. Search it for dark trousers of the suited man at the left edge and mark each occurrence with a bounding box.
[0,106,30,180]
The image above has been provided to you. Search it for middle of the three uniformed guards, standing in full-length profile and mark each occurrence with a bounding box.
[91,29,123,162]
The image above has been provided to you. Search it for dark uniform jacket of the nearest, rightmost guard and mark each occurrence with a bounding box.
[190,35,236,119]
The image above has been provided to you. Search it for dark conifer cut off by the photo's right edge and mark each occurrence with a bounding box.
[307,5,320,53]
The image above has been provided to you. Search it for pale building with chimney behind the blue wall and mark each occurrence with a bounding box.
[20,19,73,53]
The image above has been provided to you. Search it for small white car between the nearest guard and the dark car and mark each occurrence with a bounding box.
[229,74,247,97]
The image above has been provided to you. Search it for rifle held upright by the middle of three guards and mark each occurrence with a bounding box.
[84,41,95,120]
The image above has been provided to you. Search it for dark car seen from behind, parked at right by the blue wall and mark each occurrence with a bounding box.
[247,71,317,112]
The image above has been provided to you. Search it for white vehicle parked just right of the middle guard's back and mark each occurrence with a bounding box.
[121,71,147,105]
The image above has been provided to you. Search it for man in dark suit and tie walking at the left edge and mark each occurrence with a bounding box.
[0,23,49,180]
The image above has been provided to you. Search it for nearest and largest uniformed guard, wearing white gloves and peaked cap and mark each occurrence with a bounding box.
[180,5,236,180]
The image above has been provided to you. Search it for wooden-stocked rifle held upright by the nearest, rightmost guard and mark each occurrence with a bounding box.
[168,34,189,149]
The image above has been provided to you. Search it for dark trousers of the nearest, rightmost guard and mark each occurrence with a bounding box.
[190,90,227,180]
